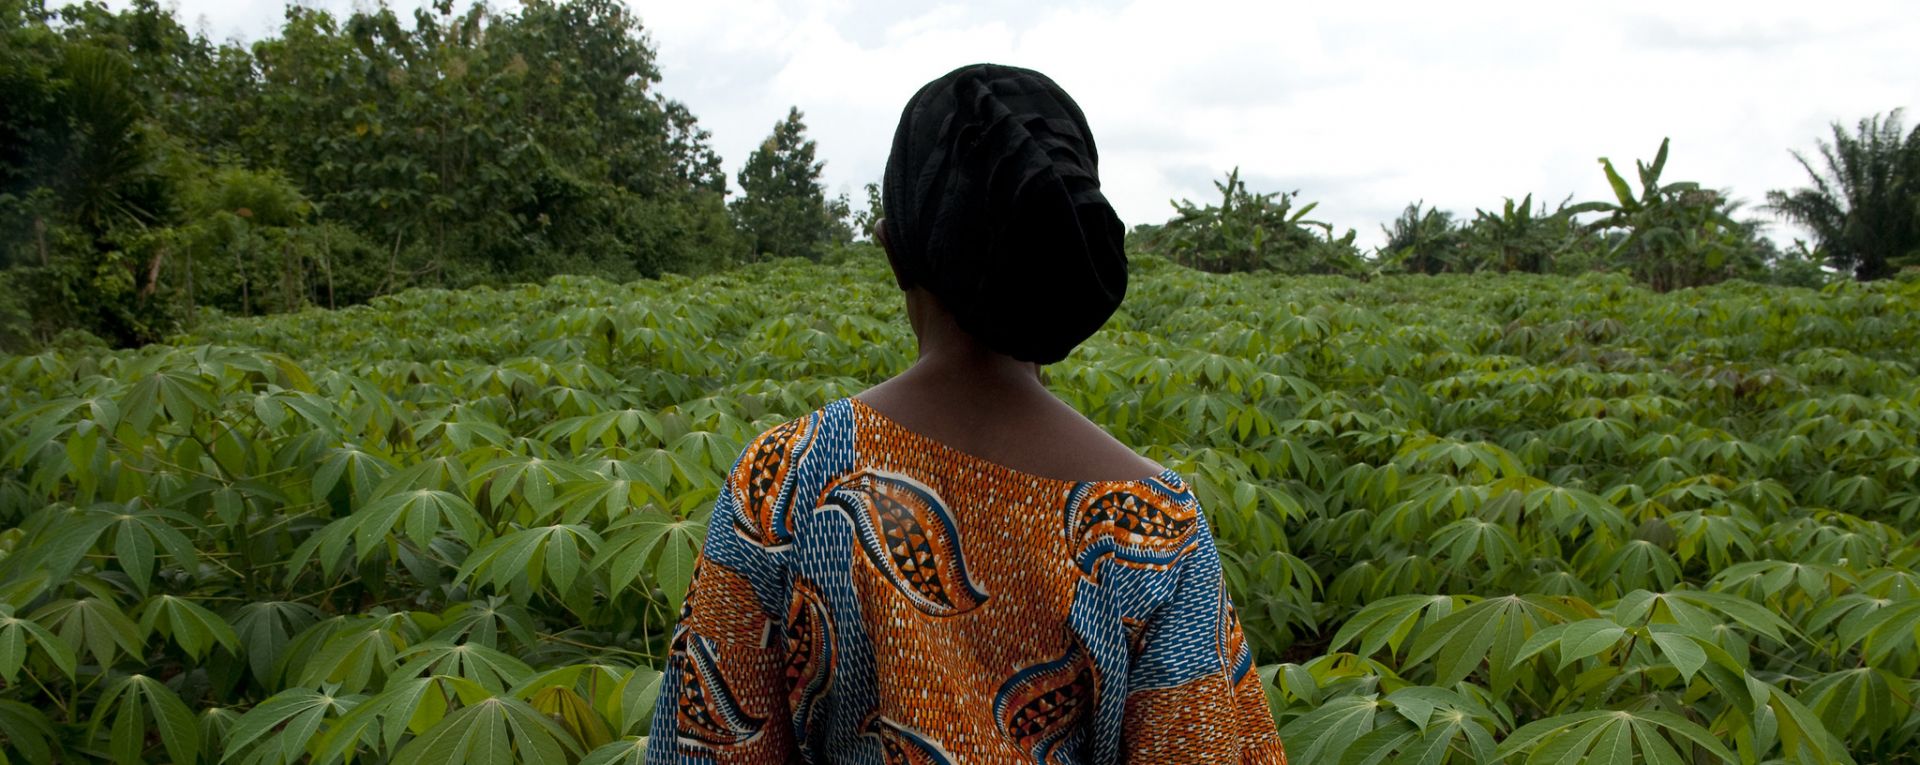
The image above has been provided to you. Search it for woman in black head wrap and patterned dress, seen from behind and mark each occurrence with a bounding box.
[647,65,1286,763]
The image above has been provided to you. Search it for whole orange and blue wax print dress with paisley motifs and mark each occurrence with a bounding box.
[647,398,1286,765]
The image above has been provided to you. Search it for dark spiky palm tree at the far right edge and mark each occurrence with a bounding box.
[1766,110,1920,281]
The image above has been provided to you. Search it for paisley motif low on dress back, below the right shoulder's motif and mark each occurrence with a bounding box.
[993,642,1100,763]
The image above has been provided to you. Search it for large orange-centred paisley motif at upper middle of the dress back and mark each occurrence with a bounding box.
[822,471,987,617]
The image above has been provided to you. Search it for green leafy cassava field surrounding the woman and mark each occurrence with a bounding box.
[0,252,1920,765]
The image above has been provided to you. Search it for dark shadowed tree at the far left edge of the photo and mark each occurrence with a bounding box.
[0,2,177,346]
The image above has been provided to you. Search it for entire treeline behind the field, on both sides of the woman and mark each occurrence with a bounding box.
[0,0,1920,350]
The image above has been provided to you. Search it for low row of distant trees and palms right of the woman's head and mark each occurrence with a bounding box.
[1133,122,1920,292]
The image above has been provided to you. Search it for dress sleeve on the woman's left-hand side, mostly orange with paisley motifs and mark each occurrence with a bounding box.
[647,423,799,765]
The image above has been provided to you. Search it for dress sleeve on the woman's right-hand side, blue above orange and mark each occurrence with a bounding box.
[1121,515,1286,765]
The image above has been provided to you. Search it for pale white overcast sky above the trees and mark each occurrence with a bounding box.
[71,0,1920,246]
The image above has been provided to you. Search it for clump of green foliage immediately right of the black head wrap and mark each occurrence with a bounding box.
[1133,167,1365,273]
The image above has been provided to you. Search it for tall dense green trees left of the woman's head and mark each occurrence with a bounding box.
[0,0,849,348]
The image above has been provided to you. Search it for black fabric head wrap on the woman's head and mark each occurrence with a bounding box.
[883,63,1127,363]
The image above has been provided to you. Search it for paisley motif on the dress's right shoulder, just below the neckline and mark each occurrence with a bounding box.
[1066,477,1200,577]
